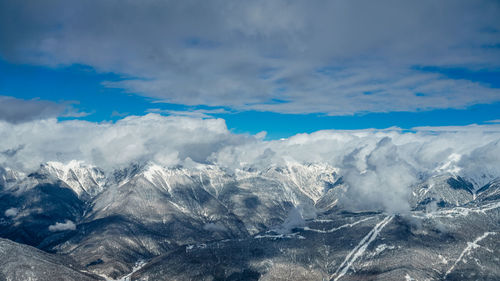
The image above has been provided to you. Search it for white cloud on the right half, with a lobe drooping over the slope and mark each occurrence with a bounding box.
[213,125,500,212]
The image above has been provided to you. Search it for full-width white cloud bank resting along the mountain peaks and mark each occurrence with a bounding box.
[0,114,500,212]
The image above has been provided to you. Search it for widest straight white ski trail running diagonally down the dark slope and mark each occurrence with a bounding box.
[330,216,394,281]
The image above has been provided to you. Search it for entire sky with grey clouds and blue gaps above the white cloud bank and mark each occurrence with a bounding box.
[0,0,500,140]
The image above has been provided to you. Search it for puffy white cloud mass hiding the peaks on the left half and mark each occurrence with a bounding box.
[0,114,252,169]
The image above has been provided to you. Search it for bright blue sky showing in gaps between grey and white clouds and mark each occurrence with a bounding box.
[0,58,500,139]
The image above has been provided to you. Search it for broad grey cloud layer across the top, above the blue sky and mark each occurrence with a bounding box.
[0,0,500,115]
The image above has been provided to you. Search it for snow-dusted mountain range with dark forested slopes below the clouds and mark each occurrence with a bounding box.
[0,161,500,280]
